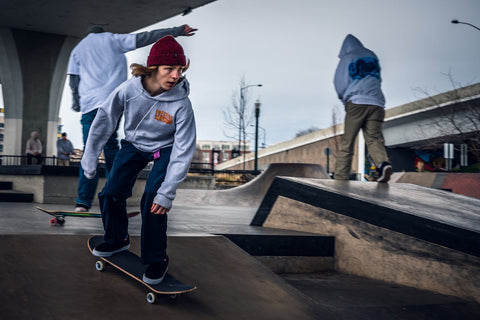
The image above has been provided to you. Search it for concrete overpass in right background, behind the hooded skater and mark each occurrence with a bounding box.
[215,83,480,173]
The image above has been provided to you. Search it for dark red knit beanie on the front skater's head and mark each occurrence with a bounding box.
[147,36,187,67]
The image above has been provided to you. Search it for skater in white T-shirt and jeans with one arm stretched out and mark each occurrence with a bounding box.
[67,24,196,212]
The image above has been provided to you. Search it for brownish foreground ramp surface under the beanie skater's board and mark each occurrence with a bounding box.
[0,235,316,320]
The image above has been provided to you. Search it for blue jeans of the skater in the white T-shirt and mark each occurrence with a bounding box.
[75,109,118,208]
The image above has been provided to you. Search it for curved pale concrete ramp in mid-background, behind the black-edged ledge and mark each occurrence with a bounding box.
[175,163,329,207]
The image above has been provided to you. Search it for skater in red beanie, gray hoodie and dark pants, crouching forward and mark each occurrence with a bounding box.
[81,36,196,284]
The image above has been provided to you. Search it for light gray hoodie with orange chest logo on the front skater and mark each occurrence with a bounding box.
[82,77,196,209]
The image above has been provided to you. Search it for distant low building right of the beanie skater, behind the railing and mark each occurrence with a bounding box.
[193,140,251,165]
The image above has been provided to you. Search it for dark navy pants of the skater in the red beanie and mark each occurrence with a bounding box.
[98,140,172,264]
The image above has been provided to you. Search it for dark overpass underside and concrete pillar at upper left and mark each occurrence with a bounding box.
[0,0,215,155]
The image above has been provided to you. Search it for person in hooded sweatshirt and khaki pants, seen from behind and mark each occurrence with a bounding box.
[334,34,392,182]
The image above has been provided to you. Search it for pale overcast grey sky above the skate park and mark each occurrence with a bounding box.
[54,0,480,148]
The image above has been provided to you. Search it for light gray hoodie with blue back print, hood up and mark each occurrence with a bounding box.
[334,34,385,108]
